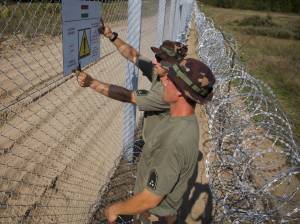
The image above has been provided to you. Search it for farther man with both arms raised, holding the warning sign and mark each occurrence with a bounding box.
[77,21,187,144]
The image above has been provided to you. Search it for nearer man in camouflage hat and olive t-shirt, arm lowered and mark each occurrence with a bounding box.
[105,59,215,224]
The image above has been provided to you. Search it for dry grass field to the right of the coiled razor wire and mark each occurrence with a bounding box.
[201,5,300,145]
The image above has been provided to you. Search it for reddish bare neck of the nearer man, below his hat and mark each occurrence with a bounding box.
[170,98,195,117]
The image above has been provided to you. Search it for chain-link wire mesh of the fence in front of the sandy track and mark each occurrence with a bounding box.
[0,0,163,223]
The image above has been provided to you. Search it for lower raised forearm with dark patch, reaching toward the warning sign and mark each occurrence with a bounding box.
[90,79,135,104]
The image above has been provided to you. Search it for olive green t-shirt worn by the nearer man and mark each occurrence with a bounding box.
[134,115,199,216]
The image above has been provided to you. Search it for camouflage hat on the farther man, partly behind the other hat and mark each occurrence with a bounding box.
[151,40,188,64]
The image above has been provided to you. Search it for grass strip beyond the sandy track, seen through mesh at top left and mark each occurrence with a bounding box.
[0,0,129,41]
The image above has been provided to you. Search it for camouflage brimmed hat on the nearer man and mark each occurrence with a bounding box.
[168,58,215,104]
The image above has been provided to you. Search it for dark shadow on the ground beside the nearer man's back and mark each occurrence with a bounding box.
[177,151,213,224]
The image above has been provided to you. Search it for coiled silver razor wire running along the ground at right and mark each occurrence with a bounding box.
[194,4,300,223]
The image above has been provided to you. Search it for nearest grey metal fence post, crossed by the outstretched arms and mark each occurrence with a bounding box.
[123,0,142,160]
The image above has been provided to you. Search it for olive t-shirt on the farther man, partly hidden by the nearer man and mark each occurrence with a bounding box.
[135,56,169,142]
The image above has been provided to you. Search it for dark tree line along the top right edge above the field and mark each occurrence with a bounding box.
[200,0,300,14]
